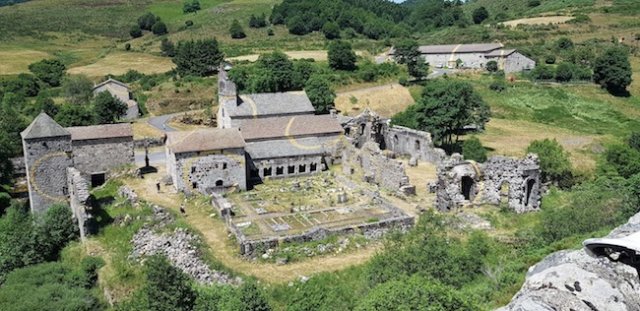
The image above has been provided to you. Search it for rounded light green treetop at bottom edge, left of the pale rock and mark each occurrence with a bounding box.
[355,275,480,311]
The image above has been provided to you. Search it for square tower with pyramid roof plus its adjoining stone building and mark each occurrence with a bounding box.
[21,112,134,213]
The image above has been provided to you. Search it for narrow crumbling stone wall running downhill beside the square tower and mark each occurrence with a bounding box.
[67,167,92,240]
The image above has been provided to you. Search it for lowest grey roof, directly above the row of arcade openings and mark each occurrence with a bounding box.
[246,137,325,160]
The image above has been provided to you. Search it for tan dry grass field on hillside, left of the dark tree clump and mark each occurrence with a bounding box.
[68,52,174,77]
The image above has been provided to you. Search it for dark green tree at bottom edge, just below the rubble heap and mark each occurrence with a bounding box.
[142,255,196,311]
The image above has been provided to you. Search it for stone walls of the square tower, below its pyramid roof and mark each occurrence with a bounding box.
[22,136,72,213]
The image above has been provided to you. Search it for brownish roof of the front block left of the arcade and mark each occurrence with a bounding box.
[167,128,245,153]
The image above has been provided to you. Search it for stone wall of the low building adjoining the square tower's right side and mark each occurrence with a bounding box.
[73,137,135,176]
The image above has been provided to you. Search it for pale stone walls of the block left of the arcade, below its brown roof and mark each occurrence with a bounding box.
[167,149,247,194]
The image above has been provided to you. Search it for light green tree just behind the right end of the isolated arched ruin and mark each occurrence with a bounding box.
[527,139,573,188]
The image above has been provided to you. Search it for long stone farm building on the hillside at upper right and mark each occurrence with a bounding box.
[389,43,536,73]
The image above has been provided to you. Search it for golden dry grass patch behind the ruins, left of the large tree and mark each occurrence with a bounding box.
[335,83,414,117]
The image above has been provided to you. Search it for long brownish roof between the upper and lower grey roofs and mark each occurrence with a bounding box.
[240,115,343,141]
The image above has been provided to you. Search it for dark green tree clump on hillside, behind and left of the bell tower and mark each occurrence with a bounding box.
[172,39,224,77]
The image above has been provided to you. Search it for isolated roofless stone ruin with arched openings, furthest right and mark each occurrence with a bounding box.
[430,154,541,213]
